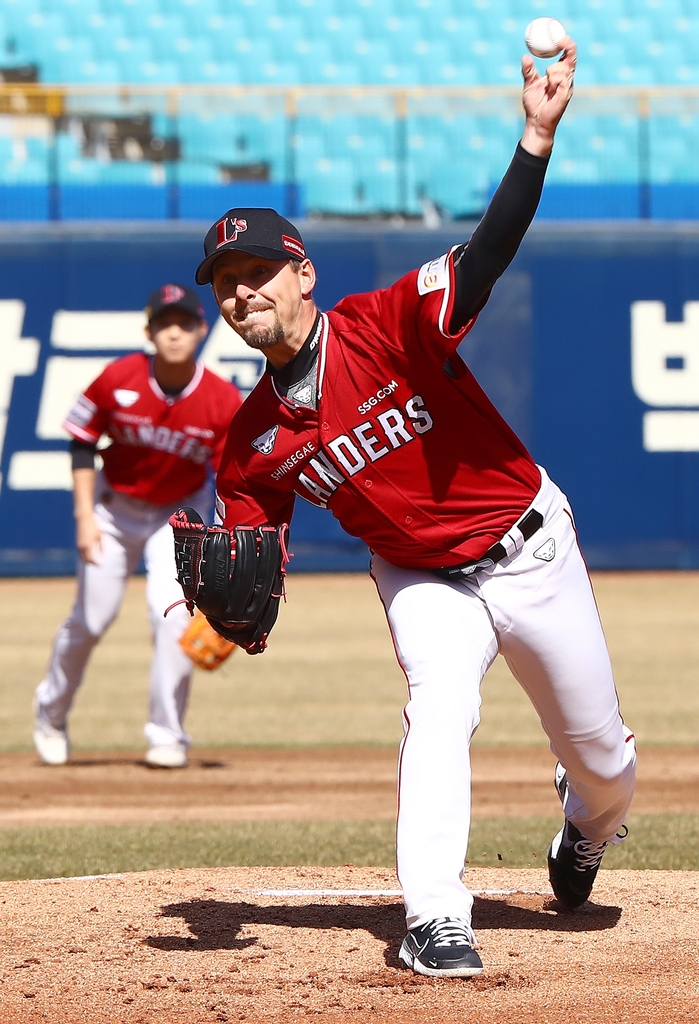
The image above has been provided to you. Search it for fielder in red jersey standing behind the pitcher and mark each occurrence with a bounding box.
[34,284,241,768]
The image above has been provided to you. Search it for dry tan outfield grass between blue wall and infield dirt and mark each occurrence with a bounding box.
[6,572,699,751]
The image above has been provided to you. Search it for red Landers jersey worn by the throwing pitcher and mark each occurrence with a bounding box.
[217,250,540,568]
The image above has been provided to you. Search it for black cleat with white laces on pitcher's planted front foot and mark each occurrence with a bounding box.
[398,918,483,978]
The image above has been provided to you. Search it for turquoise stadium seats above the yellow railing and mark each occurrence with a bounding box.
[0,0,699,84]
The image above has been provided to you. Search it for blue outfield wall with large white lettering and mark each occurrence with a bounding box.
[0,220,699,574]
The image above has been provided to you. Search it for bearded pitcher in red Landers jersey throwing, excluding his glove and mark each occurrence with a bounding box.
[183,37,636,977]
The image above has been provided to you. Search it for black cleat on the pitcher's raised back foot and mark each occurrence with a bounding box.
[548,764,628,910]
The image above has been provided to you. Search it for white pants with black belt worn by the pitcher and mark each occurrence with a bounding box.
[372,471,636,928]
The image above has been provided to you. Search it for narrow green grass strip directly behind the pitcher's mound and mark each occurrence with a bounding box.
[0,814,699,881]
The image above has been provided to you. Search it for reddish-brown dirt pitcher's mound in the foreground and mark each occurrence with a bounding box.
[0,866,699,1024]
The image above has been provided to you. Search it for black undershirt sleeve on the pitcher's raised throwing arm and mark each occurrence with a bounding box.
[449,144,549,334]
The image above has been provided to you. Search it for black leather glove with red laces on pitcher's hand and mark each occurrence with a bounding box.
[166,508,289,654]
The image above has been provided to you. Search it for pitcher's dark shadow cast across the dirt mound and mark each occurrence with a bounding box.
[143,896,621,967]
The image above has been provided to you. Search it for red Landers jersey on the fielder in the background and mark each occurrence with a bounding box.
[63,352,242,505]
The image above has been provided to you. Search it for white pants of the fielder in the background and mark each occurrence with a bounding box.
[36,475,212,745]
